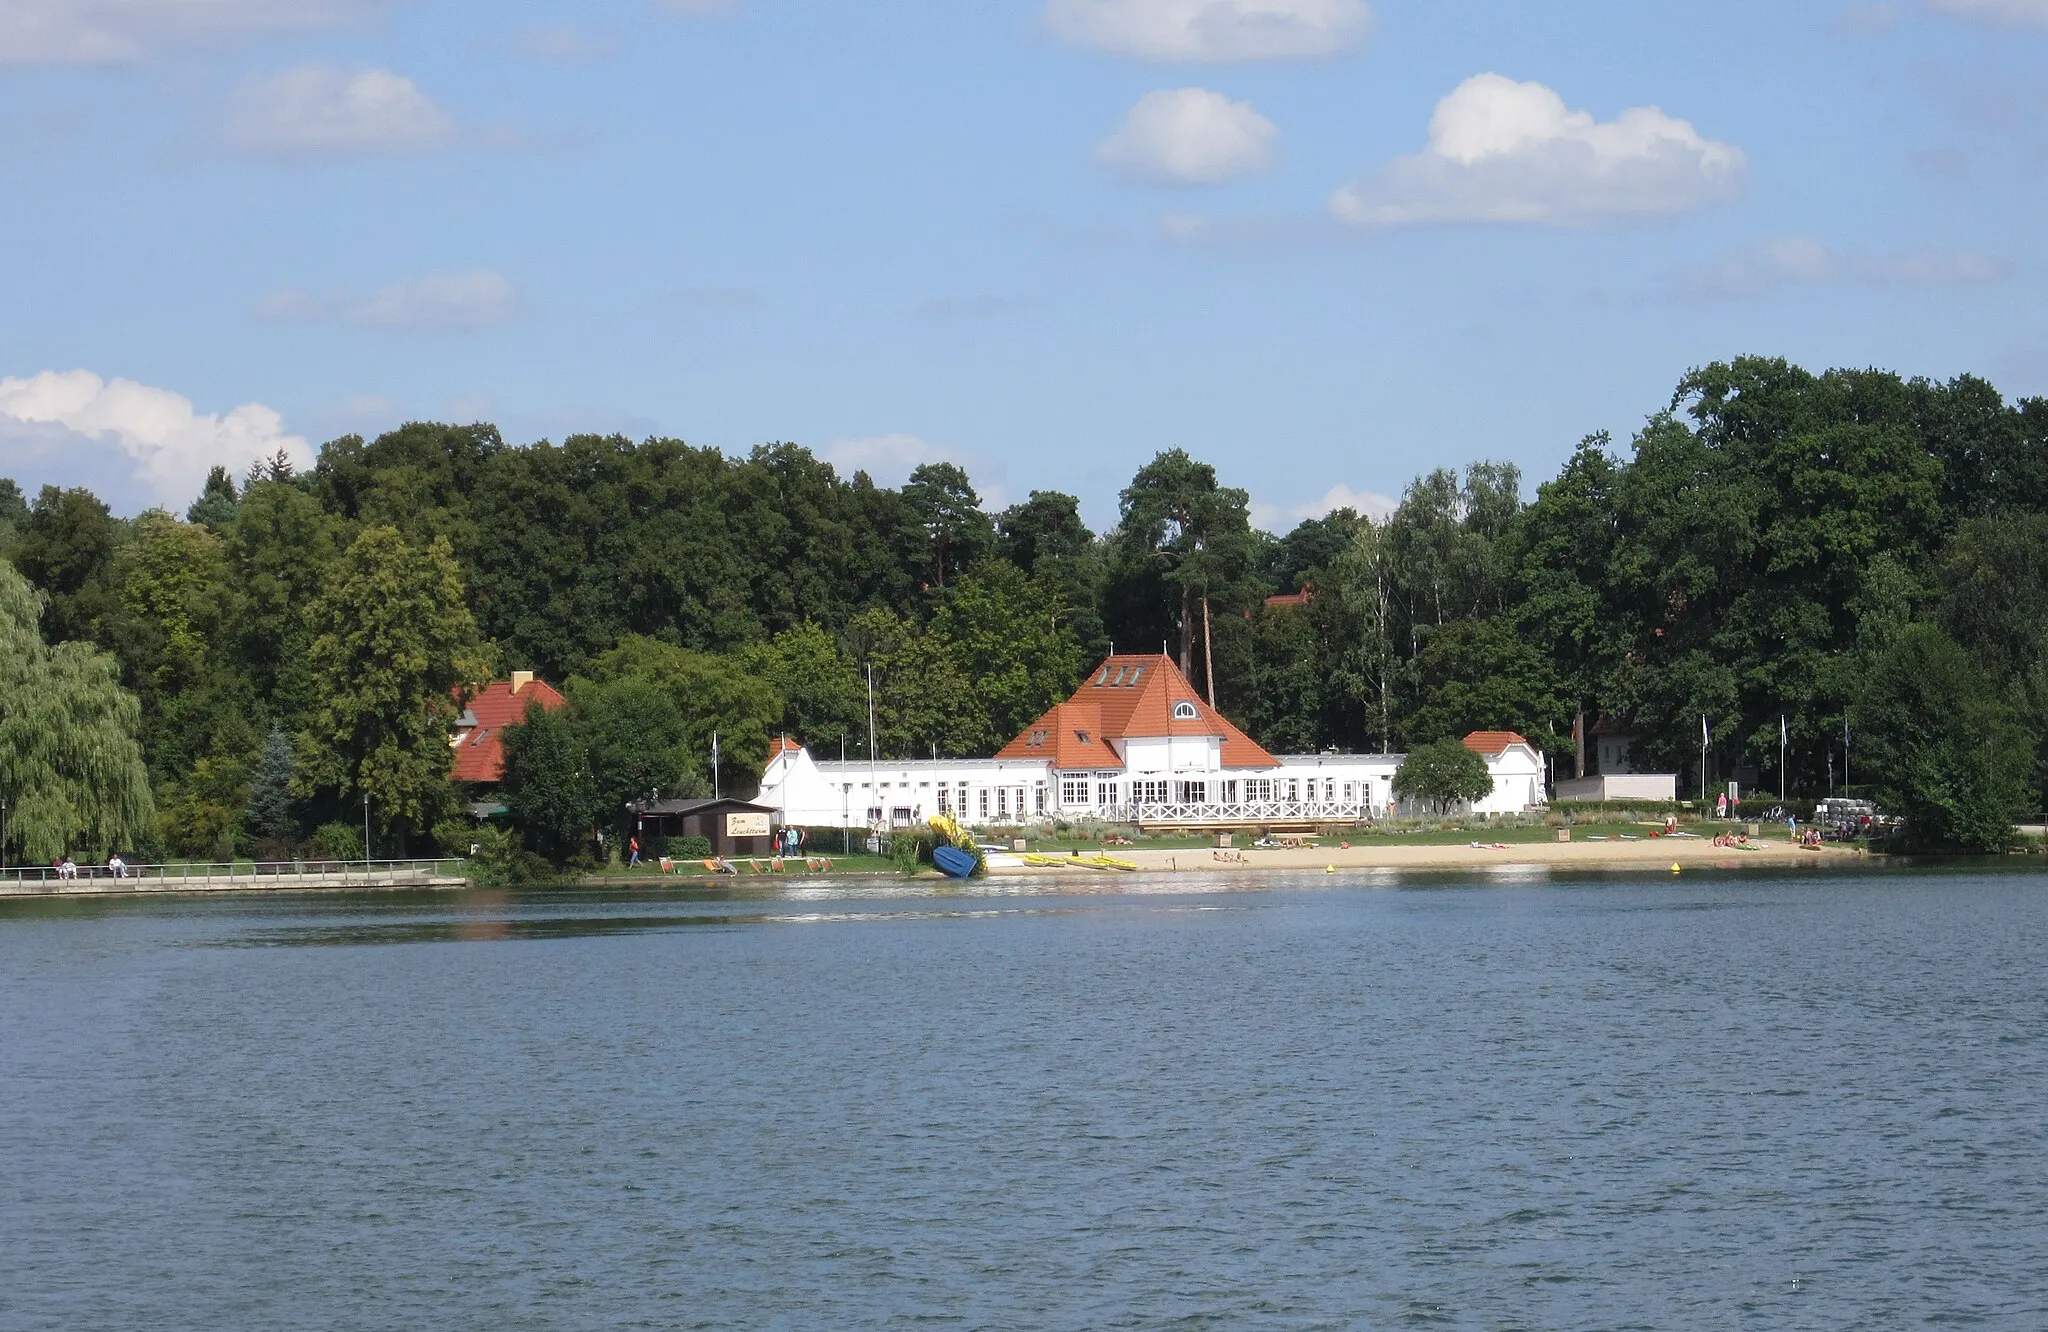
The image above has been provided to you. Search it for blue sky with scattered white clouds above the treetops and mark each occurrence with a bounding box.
[0,0,2048,531]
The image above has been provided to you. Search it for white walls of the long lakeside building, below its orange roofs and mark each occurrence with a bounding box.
[756,736,1544,828]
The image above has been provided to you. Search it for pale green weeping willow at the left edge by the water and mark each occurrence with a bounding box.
[0,561,156,861]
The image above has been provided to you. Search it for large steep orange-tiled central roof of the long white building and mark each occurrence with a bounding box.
[995,654,1278,773]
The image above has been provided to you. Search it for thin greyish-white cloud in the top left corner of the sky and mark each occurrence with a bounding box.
[0,0,381,64]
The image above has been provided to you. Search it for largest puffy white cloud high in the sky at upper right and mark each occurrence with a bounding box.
[1329,74,1745,225]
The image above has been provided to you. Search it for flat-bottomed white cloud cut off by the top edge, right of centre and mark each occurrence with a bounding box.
[1044,0,1372,64]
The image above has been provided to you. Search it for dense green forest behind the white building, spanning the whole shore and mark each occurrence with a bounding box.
[0,359,2048,859]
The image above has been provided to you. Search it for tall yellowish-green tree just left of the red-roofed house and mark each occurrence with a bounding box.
[293,527,489,834]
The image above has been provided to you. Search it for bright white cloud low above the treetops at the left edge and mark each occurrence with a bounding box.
[0,371,313,506]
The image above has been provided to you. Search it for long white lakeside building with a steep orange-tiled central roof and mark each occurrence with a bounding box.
[756,656,1544,828]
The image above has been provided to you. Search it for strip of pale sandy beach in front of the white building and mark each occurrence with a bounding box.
[989,836,1868,875]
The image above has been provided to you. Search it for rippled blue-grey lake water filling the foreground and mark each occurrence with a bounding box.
[0,871,2048,1332]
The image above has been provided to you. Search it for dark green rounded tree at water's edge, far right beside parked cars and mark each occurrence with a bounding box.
[1855,625,2034,852]
